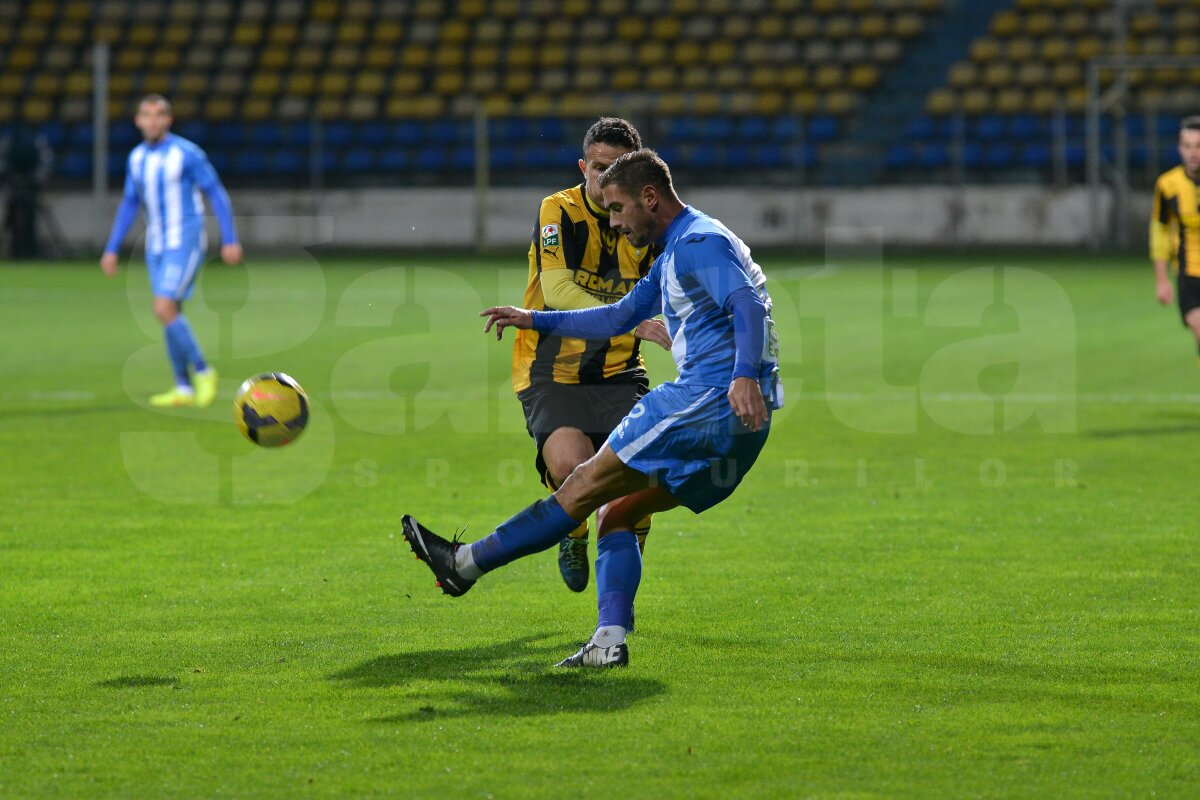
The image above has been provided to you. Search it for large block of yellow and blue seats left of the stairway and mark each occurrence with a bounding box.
[0,0,942,182]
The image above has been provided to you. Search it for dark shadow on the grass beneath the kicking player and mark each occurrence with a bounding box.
[329,634,666,722]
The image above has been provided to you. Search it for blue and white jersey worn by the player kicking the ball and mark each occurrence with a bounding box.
[533,206,782,393]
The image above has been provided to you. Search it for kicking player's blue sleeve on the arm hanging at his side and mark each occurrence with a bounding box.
[676,234,767,380]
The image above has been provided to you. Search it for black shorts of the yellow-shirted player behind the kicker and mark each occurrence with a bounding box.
[517,377,650,486]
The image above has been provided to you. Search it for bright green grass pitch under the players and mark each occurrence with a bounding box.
[0,252,1200,798]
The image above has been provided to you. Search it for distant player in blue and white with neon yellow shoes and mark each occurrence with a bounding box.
[100,95,242,405]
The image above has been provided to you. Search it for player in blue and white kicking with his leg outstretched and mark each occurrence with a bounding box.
[403,149,782,667]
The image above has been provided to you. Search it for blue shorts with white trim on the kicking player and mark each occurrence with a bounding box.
[607,383,770,513]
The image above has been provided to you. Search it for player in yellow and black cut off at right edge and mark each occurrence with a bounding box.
[1150,116,1200,348]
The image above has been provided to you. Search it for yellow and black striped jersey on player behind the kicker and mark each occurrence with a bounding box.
[512,185,656,392]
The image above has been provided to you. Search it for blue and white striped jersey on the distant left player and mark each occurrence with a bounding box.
[104,133,238,255]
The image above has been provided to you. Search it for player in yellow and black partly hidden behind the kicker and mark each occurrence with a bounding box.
[512,116,671,591]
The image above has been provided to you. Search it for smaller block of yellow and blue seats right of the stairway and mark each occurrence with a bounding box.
[887,0,1200,180]
